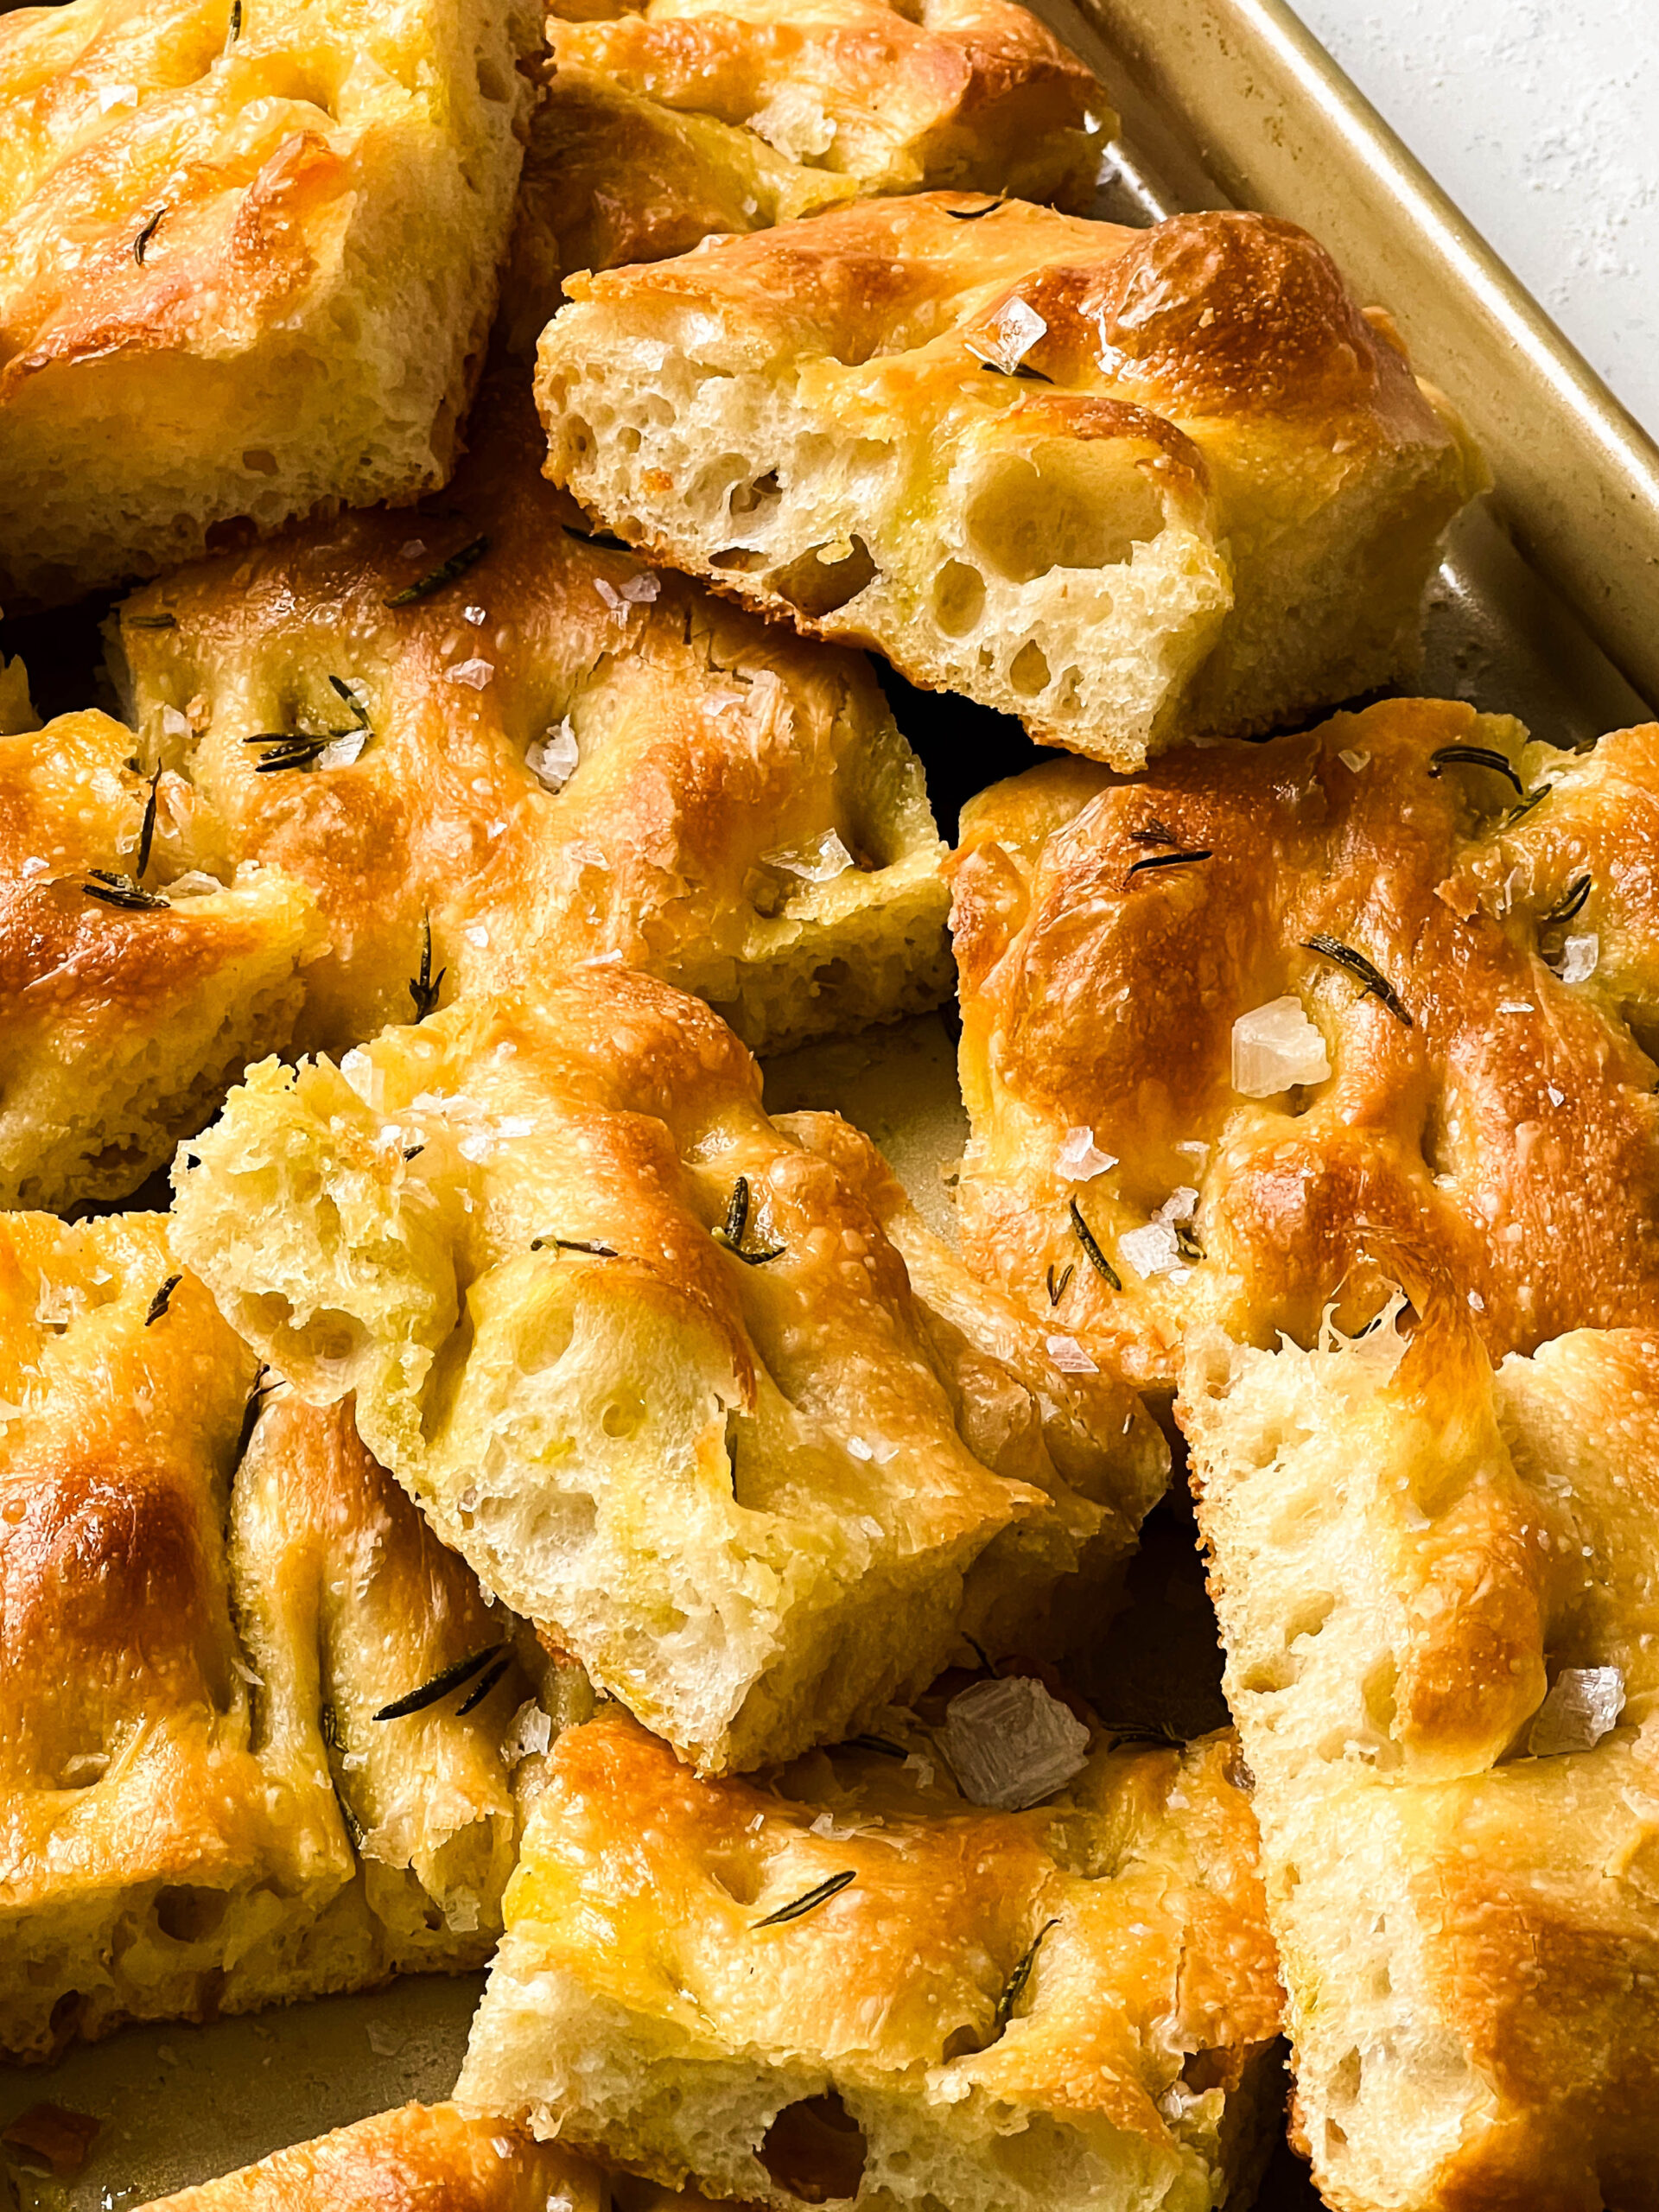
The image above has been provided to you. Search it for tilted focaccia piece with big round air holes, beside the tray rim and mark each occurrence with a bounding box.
[537,193,1482,767]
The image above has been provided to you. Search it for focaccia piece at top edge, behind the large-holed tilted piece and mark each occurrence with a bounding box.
[506,0,1117,347]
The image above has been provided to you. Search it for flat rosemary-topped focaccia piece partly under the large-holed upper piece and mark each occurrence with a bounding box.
[111,378,951,1071]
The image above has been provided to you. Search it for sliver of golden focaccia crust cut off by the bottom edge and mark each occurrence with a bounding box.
[142,2104,611,2212]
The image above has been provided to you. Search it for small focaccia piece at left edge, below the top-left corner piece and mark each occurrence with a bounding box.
[0,703,319,1208]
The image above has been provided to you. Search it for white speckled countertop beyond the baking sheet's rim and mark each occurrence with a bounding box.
[1294,0,1659,434]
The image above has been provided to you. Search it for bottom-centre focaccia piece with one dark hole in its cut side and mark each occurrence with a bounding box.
[455,1683,1281,2212]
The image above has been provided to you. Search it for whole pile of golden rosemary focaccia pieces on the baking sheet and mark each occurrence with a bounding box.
[0,0,1659,2212]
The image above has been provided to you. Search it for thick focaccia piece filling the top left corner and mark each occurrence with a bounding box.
[0,0,540,601]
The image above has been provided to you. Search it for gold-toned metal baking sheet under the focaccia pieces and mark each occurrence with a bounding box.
[0,0,1659,2212]
